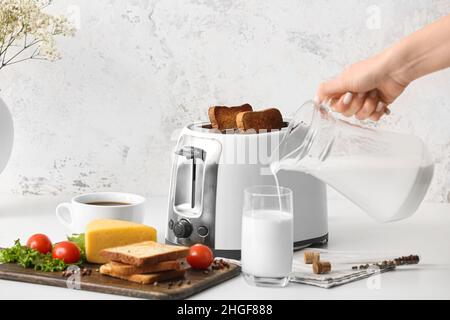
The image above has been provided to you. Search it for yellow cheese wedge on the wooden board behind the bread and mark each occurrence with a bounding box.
[85,219,156,263]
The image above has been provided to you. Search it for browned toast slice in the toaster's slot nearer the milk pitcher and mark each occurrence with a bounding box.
[236,108,284,132]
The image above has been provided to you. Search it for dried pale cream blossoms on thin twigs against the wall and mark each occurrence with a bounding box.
[0,0,75,69]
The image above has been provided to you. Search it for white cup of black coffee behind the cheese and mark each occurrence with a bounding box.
[56,192,146,233]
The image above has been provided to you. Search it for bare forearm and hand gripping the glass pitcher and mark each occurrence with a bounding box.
[317,15,450,121]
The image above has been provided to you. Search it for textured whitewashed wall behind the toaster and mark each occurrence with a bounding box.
[0,0,450,201]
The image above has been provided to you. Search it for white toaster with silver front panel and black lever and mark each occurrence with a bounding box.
[166,123,328,258]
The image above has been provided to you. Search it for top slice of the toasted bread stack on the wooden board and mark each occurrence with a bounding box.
[100,241,189,266]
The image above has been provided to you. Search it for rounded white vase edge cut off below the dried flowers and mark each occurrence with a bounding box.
[0,98,14,173]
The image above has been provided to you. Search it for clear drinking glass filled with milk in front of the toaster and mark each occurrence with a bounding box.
[241,186,293,287]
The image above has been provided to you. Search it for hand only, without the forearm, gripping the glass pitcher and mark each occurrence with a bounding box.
[316,55,409,121]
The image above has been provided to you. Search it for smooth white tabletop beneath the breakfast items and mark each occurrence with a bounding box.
[0,197,450,300]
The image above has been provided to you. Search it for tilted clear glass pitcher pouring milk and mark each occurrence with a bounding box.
[271,101,434,222]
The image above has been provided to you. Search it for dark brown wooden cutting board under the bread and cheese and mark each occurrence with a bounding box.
[0,263,241,300]
